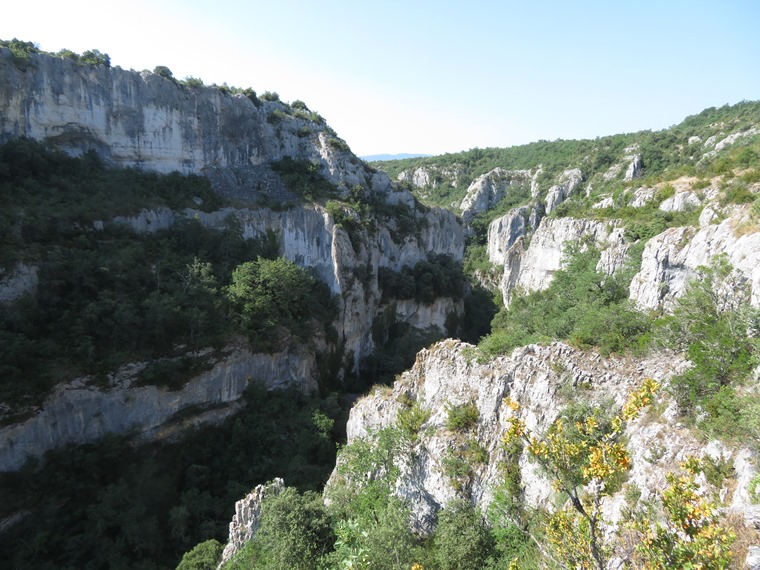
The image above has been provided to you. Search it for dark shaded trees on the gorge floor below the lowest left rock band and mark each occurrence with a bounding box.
[0,386,346,569]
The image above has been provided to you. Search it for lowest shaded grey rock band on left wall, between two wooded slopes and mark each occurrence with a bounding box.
[0,348,317,471]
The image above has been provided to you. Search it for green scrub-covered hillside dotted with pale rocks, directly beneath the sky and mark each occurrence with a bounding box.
[373,101,760,220]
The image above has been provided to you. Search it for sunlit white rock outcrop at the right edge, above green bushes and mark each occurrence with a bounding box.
[630,209,760,310]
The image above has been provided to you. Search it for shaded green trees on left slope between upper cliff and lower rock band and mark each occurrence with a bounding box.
[0,139,337,403]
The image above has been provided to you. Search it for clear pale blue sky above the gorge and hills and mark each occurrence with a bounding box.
[0,0,760,155]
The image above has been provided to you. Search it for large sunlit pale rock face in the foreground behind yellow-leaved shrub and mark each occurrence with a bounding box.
[328,340,756,531]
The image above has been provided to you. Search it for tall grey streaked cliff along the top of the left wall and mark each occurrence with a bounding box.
[0,48,382,198]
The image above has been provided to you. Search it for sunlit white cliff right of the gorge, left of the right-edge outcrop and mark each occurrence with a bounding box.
[489,218,628,304]
